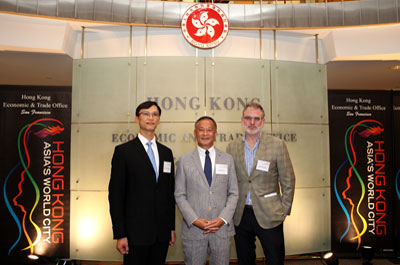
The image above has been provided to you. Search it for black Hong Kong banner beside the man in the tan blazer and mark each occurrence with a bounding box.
[328,90,396,253]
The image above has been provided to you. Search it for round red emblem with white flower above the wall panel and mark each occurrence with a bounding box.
[181,4,229,49]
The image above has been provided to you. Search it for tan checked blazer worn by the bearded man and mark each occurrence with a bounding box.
[227,134,295,229]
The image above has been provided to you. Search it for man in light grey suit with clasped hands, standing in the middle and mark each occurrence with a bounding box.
[175,116,238,265]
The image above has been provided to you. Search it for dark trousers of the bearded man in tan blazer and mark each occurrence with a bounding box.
[235,208,285,265]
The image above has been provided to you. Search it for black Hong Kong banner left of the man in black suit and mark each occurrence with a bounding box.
[0,86,71,260]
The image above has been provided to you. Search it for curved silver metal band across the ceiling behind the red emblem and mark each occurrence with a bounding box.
[0,0,400,29]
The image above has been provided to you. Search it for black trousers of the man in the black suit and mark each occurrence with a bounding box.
[124,241,168,265]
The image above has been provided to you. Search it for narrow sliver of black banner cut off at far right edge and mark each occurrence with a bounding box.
[393,91,400,254]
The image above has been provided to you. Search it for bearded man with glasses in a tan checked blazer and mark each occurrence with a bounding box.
[227,102,295,265]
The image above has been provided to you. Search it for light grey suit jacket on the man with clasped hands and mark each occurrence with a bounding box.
[175,148,239,240]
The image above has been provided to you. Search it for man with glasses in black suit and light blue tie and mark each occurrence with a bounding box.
[108,101,175,265]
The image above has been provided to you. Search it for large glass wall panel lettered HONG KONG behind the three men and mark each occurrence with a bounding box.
[71,57,330,261]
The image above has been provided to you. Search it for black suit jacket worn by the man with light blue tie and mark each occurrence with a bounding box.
[108,137,175,245]
